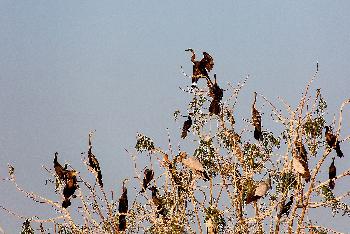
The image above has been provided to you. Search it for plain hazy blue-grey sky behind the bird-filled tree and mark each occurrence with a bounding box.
[0,0,350,233]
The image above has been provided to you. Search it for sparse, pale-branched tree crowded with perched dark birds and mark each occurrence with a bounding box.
[2,50,350,233]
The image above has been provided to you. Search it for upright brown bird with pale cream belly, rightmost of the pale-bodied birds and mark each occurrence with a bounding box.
[293,140,311,182]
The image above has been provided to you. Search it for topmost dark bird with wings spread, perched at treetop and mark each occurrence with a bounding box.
[185,48,214,86]
